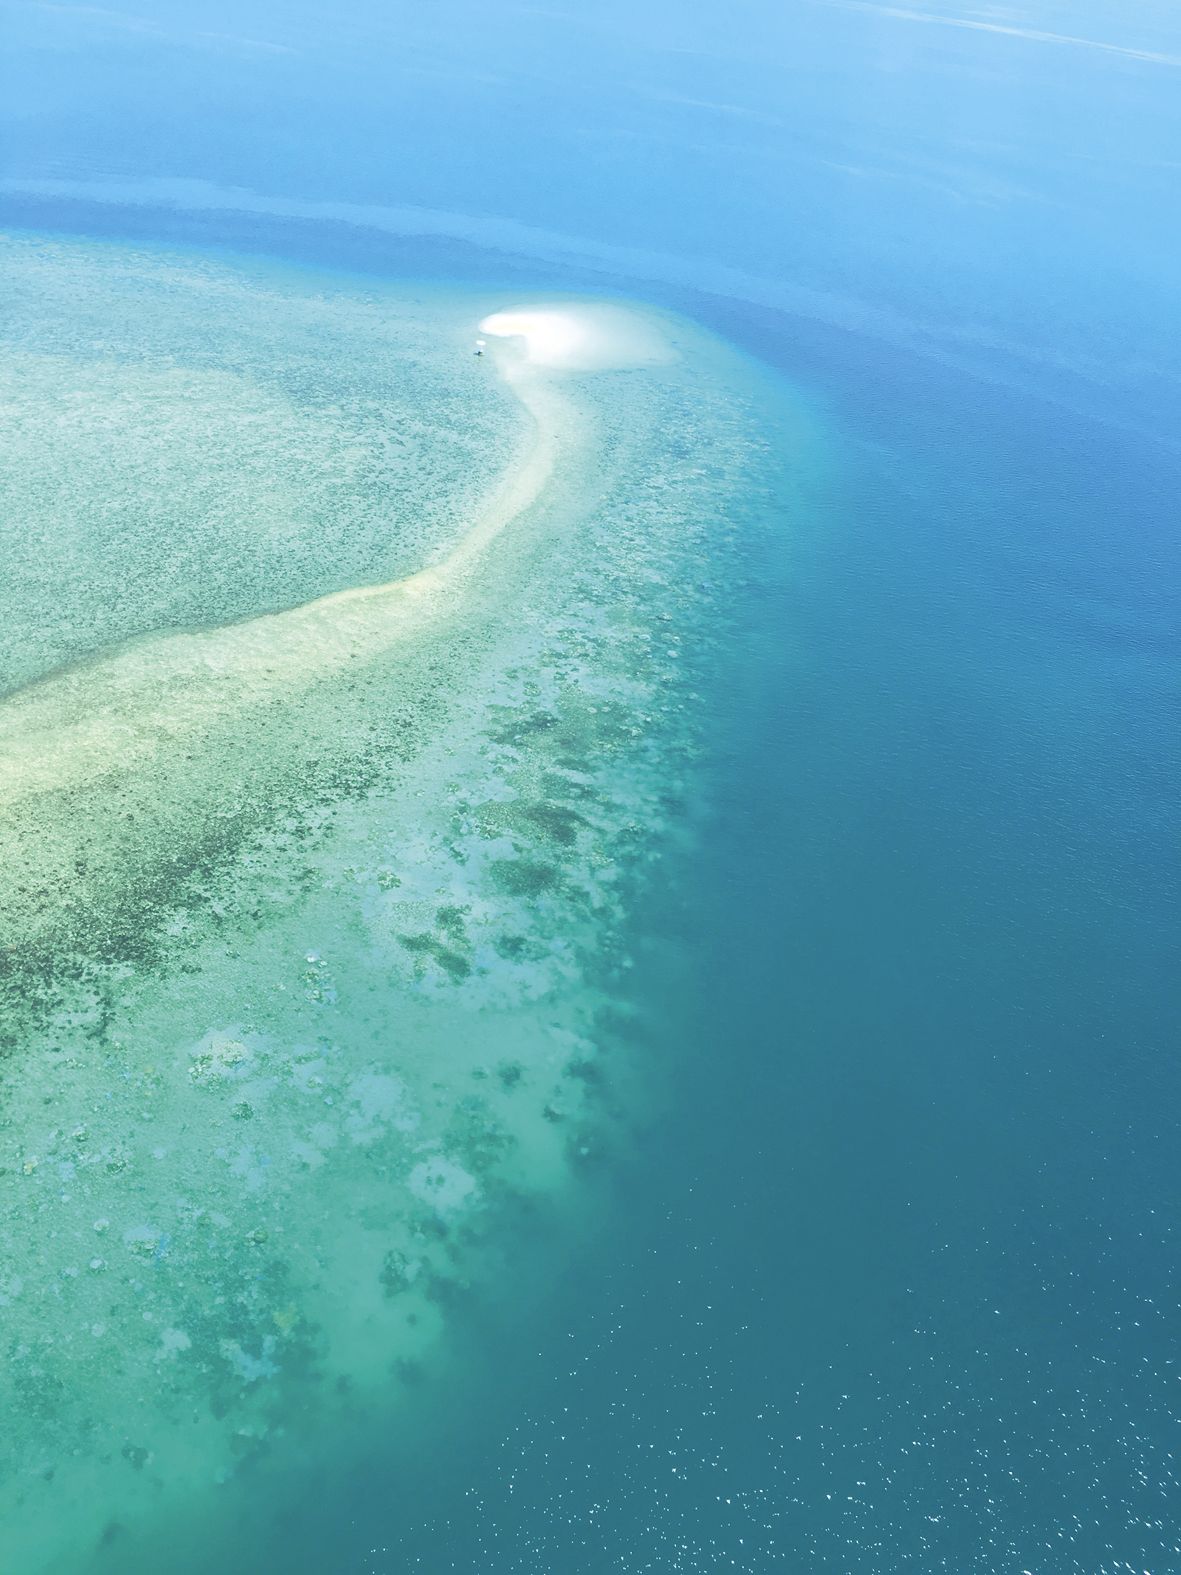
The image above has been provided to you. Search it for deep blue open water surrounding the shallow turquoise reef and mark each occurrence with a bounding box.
[8,5,1181,1575]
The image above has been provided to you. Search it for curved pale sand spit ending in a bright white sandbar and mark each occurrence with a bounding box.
[0,306,674,813]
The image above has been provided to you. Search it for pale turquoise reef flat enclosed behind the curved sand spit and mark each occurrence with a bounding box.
[0,236,521,691]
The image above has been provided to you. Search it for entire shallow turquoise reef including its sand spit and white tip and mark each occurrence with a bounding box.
[0,238,811,1575]
